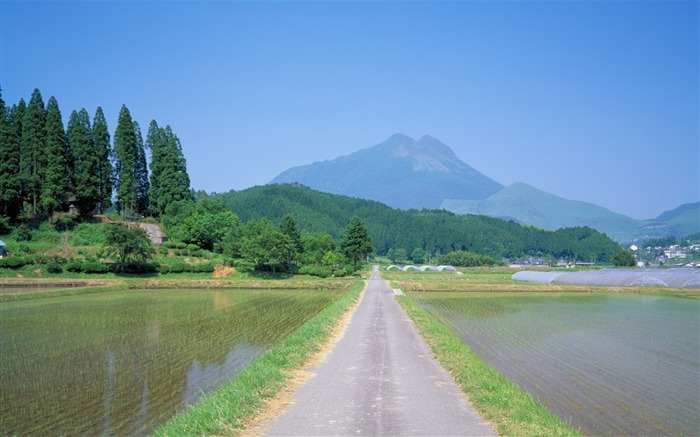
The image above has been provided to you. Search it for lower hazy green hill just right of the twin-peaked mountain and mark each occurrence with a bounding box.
[441,182,640,241]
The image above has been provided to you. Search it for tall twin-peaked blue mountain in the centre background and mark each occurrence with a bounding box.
[272,134,503,209]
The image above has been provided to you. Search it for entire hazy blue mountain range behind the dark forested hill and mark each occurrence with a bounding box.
[272,134,700,242]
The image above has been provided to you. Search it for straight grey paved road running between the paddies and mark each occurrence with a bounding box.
[266,267,495,436]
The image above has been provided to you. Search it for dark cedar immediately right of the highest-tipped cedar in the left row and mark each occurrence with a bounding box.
[41,97,69,214]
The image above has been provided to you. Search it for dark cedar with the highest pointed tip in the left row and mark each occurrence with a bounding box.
[20,88,46,214]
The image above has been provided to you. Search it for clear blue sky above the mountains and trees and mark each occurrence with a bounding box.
[0,0,700,218]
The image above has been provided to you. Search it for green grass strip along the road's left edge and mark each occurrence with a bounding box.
[154,281,364,436]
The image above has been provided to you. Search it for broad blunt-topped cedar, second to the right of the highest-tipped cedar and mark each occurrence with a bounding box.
[67,108,100,216]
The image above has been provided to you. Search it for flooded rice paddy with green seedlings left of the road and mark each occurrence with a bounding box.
[0,290,338,435]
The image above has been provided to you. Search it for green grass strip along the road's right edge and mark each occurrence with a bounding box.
[397,296,581,436]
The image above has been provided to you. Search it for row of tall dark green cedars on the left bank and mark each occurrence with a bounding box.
[0,89,190,226]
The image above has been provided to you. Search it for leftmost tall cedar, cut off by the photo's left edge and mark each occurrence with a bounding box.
[0,92,21,220]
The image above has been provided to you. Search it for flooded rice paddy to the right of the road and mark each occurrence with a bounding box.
[410,293,700,435]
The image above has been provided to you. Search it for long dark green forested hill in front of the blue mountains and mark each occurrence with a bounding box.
[213,184,618,261]
